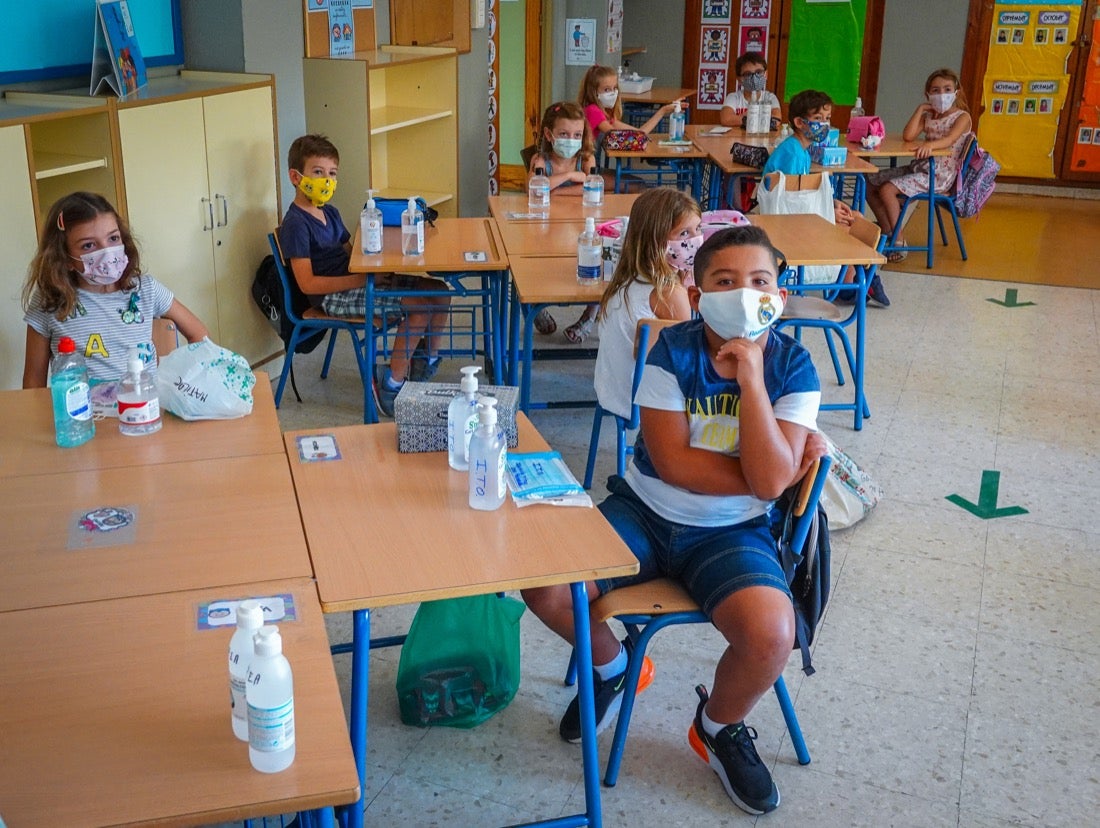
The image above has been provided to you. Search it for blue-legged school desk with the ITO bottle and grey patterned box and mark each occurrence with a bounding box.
[284,415,638,828]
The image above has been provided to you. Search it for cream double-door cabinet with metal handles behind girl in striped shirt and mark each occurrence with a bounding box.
[117,71,283,364]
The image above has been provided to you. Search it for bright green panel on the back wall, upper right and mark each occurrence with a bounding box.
[783,0,867,106]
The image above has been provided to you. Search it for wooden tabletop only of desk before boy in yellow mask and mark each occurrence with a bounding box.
[348,218,508,273]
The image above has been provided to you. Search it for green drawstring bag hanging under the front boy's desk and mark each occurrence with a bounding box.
[397,595,526,728]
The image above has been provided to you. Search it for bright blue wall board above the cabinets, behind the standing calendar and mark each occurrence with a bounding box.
[0,0,184,85]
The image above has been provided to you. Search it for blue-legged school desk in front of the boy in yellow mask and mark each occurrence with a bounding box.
[348,218,508,422]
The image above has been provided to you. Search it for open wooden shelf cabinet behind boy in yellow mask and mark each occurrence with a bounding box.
[304,46,459,227]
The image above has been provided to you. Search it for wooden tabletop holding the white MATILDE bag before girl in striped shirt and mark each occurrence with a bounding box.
[0,372,283,477]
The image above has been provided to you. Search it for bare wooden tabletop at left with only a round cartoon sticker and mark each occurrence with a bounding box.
[0,448,312,612]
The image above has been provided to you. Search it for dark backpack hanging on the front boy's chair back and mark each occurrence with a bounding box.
[776,486,833,675]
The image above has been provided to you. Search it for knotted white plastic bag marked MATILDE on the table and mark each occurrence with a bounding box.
[156,338,256,420]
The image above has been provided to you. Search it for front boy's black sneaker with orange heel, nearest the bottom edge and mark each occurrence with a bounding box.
[688,684,779,814]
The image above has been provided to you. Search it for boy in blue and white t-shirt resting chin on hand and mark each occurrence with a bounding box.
[524,227,825,814]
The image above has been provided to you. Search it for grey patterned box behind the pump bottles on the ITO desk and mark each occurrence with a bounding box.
[394,383,519,453]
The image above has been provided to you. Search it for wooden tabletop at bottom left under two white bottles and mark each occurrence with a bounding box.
[0,576,359,828]
